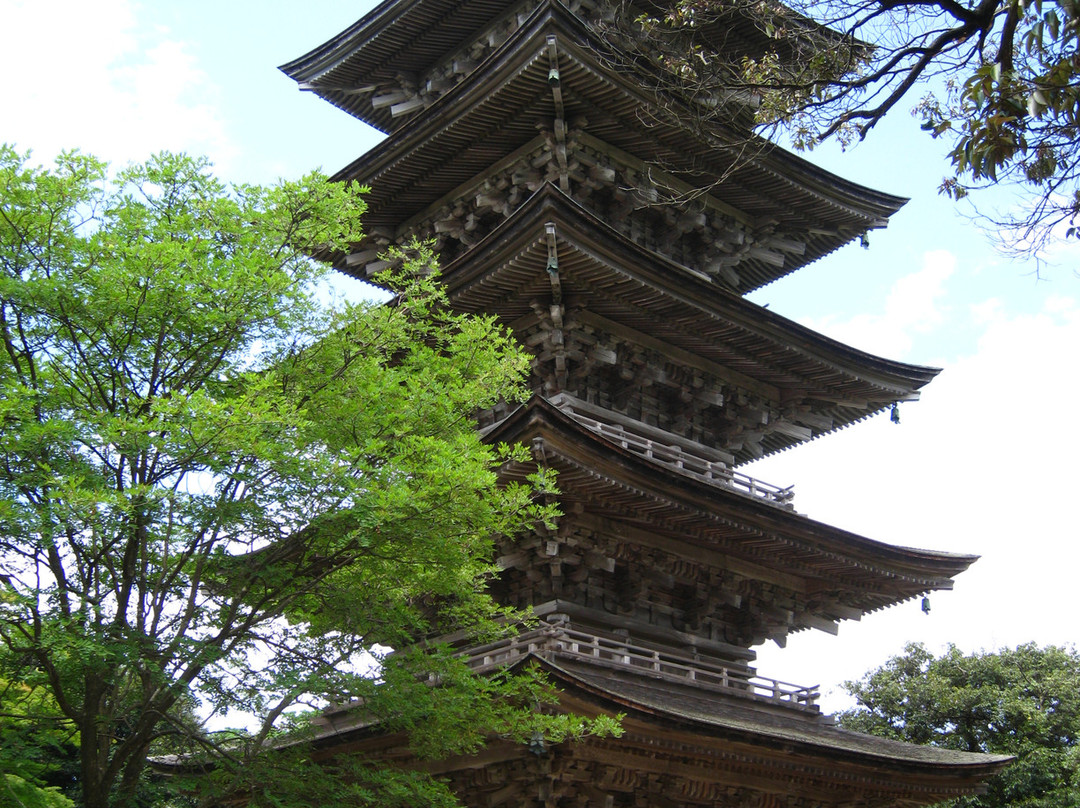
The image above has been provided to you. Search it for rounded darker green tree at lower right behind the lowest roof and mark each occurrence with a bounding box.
[838,644,1080,808]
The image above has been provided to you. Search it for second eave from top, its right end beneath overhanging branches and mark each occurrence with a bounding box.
[313,1,905,288]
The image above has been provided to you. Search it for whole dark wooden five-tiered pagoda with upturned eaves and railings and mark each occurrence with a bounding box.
[283,0,1004,808]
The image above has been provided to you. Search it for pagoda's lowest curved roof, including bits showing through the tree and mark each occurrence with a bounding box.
[230,654,1014,806]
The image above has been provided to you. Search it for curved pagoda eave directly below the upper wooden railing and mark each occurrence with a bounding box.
[485,396,978,617]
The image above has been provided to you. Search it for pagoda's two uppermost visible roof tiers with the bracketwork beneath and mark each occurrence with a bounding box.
[283,0,904,293]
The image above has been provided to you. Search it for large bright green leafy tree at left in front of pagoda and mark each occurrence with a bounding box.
[0,147,596,808]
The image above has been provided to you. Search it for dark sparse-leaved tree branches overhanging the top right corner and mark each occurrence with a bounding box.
[637,0,1080,252]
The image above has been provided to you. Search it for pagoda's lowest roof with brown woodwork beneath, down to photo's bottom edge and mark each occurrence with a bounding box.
[302,658,1011,808]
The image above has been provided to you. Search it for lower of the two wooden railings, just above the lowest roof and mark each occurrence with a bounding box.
[467,627,820,713]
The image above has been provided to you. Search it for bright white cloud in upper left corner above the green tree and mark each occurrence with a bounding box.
[0,0,234,164]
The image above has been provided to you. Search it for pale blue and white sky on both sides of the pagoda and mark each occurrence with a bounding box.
[0,0,1080,709]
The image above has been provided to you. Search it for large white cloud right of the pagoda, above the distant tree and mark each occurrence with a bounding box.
[747,260,1080,709]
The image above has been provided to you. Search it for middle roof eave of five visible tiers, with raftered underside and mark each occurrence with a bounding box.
[444,186,937,460]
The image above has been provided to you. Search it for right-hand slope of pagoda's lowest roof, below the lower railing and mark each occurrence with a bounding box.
[541,663,1012,805]
